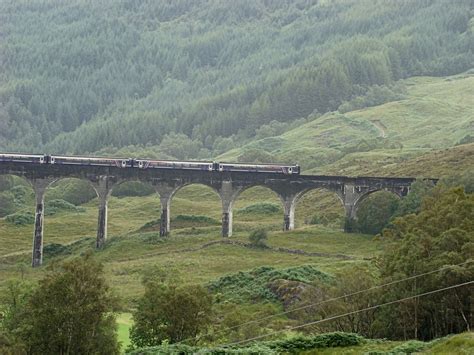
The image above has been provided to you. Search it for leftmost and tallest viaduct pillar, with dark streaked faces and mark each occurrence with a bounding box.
[31,179,51,267]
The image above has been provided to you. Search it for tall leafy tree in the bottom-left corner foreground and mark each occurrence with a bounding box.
[20,254,120,354]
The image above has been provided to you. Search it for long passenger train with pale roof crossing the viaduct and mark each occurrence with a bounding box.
[0,153,300,175]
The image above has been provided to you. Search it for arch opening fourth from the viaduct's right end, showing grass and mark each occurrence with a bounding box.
[170,184,222,234]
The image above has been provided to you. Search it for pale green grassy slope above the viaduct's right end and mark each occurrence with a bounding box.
[219,73,474,175]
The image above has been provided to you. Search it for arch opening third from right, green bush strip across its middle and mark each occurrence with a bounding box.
[233,186,284,232]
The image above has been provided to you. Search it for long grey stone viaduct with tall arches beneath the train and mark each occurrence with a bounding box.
[0,162,422,267]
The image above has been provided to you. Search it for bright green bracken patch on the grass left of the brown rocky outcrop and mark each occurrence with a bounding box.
[208,265,331,302]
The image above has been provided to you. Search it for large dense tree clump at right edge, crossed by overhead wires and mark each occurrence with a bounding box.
[377,186,474,340]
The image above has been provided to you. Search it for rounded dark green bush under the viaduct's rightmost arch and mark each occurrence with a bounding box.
[357,192,399,234]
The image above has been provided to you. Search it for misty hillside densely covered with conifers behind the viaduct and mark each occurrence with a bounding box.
[0,0,474,158]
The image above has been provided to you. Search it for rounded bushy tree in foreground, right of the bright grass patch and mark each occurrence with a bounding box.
[130,282,212,347]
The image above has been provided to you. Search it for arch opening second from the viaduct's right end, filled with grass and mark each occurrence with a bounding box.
[295,188,345,229]
